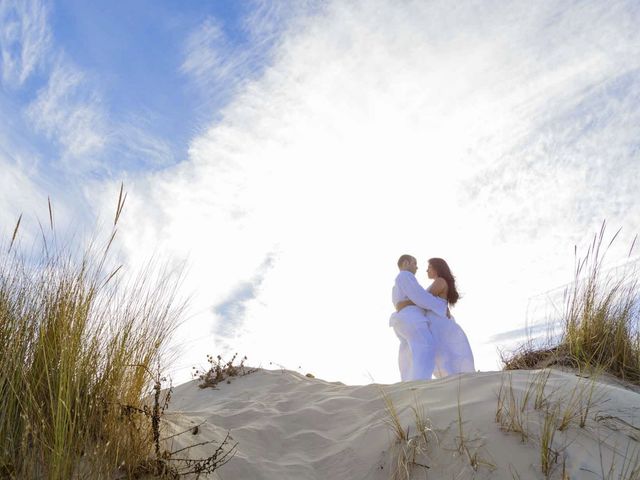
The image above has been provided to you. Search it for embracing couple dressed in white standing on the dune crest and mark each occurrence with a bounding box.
[389,255,475,382]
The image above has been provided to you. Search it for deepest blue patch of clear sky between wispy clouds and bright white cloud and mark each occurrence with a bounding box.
[51,1,288,159]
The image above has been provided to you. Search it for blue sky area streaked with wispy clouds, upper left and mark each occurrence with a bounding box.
[2,1,298,177]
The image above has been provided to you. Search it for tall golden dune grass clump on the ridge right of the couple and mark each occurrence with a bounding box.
[502,223,640,384]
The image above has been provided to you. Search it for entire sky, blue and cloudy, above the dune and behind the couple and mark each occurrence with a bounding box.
[0,0,640,384]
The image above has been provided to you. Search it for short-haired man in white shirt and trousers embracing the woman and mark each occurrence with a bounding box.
[389,255,447,382]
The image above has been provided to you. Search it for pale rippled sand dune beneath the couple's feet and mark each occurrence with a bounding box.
[163,370,640,480]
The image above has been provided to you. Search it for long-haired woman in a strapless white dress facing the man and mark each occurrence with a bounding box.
[396,258,475,378]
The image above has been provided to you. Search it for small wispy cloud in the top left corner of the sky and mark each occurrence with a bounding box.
[0,0,51,87]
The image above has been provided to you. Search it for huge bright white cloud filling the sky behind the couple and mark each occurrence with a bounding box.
[89,1,640,382]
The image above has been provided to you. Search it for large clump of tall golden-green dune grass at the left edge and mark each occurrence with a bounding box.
[0,189,182,480]
